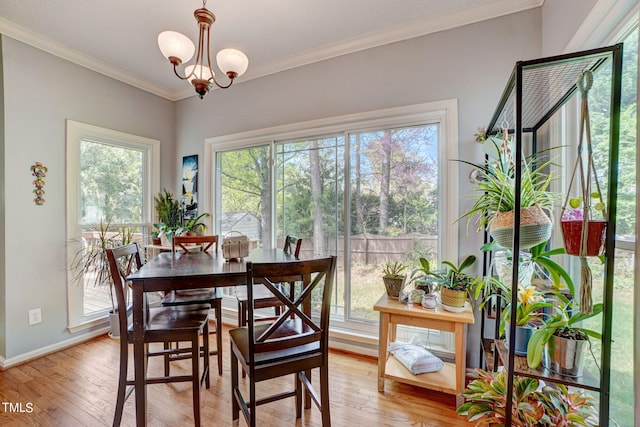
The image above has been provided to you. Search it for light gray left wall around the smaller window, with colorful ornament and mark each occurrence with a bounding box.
[0,36,175,361]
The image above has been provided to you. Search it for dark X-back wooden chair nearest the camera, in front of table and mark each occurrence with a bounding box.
[229,256,336,427]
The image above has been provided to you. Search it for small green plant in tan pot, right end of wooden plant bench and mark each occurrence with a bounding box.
[440,255,476,311]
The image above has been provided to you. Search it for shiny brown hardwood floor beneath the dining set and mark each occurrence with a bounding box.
[0,327,471,427]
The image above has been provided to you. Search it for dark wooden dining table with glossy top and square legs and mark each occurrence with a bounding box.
[127,249,297,426]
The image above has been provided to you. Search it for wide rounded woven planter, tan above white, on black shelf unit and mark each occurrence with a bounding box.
[489,206,552,249]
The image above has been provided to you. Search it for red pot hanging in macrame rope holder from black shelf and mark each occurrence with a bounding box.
[560,70,608,313]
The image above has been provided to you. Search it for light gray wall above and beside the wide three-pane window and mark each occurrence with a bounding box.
[176,9,542,366]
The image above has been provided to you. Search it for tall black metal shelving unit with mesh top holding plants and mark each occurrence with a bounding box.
[483,44,622,427]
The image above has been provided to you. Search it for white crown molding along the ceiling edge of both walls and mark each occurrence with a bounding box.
[0,0,544,101]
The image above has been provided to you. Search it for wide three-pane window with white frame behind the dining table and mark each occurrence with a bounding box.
[207,101,458,338]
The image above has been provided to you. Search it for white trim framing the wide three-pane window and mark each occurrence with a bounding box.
[203,99,459,336]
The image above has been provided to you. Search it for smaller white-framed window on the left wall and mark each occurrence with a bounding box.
[67,121,159,331]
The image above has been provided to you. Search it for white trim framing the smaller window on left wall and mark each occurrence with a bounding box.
[66,120,160,332]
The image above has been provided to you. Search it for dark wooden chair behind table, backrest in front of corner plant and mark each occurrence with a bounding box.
[162,235,222,375]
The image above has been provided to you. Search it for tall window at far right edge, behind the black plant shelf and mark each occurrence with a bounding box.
[585,25,639,427]
